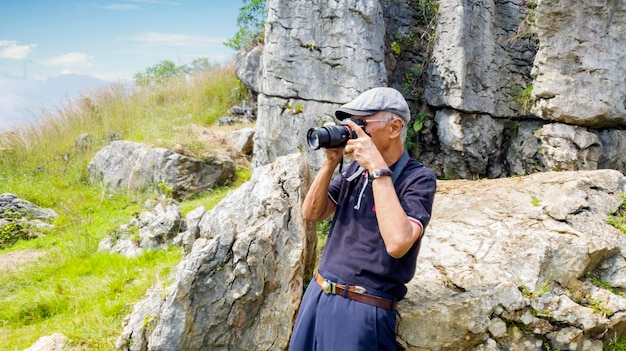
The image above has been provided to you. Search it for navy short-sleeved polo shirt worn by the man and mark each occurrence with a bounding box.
[320,159,436,300]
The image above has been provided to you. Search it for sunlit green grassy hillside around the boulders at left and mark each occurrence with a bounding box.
[0,67,250,350]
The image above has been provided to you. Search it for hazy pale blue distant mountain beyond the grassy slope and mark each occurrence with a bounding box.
[0,74,111,132]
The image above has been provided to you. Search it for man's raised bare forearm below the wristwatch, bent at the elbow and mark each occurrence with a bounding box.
[372,177,422,258]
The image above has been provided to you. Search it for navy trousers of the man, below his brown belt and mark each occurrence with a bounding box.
[289,274,396,351]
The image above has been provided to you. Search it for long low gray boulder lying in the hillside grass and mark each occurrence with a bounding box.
[88,141,235,199]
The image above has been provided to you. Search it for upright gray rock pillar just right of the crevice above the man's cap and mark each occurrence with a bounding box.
[424,0,537,117]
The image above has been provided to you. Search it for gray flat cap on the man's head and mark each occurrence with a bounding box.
[335,87,411,123]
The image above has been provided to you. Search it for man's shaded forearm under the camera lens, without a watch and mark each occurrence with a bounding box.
[302,159,337,222]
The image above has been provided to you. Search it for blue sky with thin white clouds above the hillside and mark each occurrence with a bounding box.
[0,0,243,81]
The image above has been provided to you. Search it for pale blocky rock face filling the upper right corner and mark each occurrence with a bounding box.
[532,0,626,129]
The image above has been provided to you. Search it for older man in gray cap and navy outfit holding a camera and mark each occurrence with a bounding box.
[289,87,436,351]
